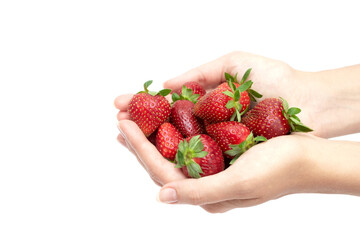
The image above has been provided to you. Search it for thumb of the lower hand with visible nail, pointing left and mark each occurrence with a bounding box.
[158,171,238,205]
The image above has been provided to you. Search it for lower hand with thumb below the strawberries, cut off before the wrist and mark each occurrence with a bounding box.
[159,133,316,212]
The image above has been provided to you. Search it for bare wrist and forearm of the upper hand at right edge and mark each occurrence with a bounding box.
[294,65,360,138]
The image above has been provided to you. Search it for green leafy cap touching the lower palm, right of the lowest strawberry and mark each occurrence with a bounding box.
[225,132,267,164]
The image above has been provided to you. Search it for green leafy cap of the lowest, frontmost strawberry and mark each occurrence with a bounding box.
[175,135,208,178]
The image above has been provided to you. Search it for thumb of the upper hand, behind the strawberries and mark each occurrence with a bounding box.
[164,54,229,89]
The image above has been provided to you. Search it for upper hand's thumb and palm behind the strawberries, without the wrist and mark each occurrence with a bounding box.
[164,51,324,136]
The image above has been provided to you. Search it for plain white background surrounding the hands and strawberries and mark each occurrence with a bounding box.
[0,0,360,239]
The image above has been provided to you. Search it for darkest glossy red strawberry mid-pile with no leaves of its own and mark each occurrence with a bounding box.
[170,100,204,137]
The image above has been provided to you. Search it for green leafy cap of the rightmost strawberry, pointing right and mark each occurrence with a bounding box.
[279,97,313,132]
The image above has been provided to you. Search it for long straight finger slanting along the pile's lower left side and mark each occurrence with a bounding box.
[118,120,185,184]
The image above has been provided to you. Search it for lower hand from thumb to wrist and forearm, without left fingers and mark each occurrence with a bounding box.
[159,133,360,213]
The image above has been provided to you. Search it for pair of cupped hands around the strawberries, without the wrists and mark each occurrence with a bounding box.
[115,52,322,213]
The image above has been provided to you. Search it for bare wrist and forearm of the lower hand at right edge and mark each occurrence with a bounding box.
[299,137,360,195]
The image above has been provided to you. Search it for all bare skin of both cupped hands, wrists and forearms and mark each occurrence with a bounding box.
[115,52,360,212]
